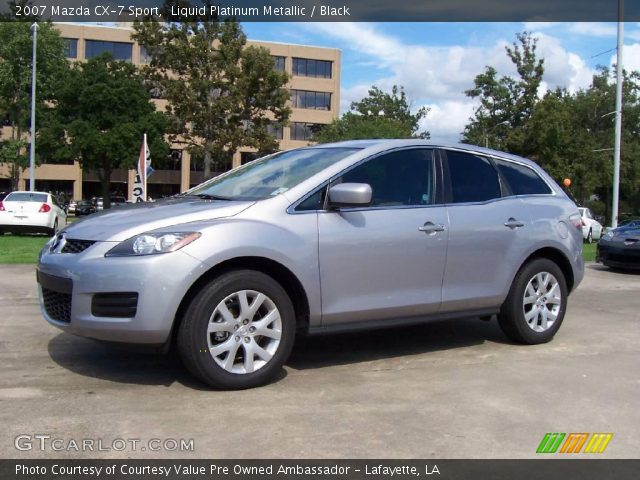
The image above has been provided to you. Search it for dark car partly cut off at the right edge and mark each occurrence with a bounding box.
[596,224,640,269]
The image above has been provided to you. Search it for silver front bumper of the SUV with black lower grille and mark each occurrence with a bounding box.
[37,242,206,345]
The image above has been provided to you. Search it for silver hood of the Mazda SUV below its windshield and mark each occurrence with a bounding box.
[63,198,255,242]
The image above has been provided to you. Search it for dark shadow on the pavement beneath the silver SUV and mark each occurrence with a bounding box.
[48,318,508,390]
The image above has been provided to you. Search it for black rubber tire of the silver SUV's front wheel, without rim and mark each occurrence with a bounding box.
[177,270,296,390]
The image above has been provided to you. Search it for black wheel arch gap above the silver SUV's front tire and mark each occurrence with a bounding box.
[170,256,309,343]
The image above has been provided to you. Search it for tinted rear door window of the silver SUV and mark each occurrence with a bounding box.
[447,151,501,203]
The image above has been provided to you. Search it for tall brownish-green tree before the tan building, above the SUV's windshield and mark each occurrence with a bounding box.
[134,12,291,178]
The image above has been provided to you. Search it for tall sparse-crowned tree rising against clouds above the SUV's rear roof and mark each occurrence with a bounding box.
[463,32,544,153]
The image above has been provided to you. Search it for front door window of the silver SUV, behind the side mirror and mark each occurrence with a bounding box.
[339,149,434,207]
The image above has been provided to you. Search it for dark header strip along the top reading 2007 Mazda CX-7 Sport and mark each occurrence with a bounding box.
[0,0,640,22]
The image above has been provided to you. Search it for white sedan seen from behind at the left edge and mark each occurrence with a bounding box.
[0,192,67,235]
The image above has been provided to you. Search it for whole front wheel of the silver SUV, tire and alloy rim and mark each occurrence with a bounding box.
[178,270,295,390]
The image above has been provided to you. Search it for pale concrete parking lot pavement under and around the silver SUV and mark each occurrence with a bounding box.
[0,264,640,459]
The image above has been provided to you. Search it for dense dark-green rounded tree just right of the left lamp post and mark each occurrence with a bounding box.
[41,54,168,208]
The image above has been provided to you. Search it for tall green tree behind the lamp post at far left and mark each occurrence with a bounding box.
[0,6,69,189]
